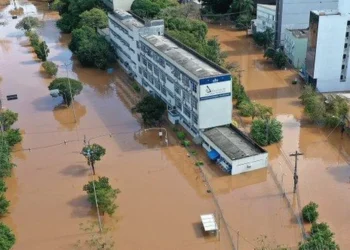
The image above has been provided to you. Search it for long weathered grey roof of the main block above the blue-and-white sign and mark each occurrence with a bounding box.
[143,35,223,78]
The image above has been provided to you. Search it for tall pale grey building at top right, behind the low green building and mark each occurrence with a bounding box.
[276,0,338,45]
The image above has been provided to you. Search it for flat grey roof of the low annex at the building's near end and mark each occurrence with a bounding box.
[204,126,266,160]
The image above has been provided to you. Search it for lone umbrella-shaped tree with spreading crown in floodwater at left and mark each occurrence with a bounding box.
[49,77,83,106]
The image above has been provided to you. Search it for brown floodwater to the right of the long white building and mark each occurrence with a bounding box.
[209,26,350,249]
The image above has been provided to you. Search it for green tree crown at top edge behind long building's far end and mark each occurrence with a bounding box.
[131,0,177,18]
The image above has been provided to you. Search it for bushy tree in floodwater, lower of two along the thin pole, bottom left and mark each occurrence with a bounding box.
[83,177,120,215]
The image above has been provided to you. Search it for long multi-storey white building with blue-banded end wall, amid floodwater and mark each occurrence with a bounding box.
[109,10,267,176]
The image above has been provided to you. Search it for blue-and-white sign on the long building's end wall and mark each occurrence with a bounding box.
[199,81,231,101]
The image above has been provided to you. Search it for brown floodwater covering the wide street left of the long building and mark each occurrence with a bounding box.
[0,1,235,250]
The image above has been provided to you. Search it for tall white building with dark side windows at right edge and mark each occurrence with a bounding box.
[306,3,350,92]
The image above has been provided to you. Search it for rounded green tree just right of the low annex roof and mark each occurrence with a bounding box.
[250,119,283,146]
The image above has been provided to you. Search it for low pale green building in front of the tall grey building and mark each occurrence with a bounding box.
[284,29,309,69]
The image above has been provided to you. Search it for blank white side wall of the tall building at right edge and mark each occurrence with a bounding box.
[314,15,350,92]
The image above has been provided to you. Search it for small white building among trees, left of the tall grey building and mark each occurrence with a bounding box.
[252,4,276,33]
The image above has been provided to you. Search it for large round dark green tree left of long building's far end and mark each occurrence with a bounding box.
[69,26,114,69]
